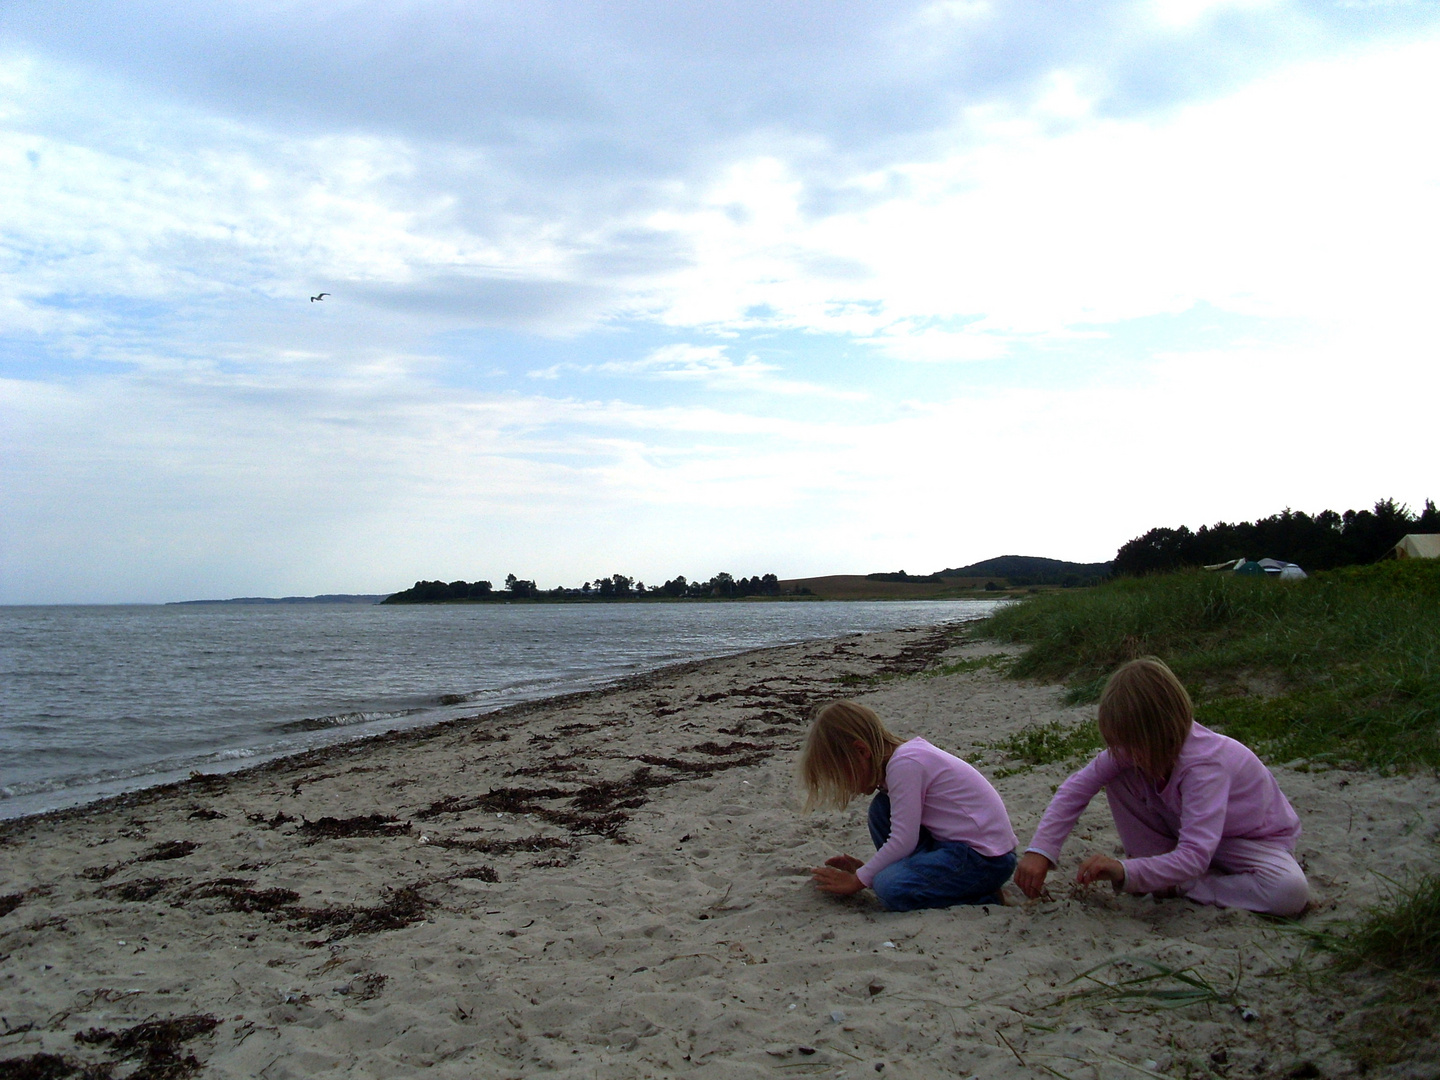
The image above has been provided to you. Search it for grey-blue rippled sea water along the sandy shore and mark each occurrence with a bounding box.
[0,600,995,818]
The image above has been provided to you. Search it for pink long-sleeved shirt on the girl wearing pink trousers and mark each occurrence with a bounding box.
[1025,724,1300,893]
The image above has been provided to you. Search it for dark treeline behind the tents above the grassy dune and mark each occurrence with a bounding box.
[1115,498,1440,576]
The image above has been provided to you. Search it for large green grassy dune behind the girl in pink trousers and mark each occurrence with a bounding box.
[979,559,1440,769]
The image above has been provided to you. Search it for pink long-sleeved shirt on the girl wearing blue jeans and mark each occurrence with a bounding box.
[855,739,1015,887]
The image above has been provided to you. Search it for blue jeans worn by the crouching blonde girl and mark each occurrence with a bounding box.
[870,791,1017,912]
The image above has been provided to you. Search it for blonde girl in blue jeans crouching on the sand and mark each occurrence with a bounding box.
[799,701,1015,912]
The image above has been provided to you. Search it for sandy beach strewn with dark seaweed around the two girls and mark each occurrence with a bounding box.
[0,628,1440,1080]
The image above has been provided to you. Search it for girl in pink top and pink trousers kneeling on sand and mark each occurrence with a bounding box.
[1015,657,1310,916]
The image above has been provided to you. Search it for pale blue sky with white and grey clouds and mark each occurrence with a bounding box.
[0,0,1440,603]
